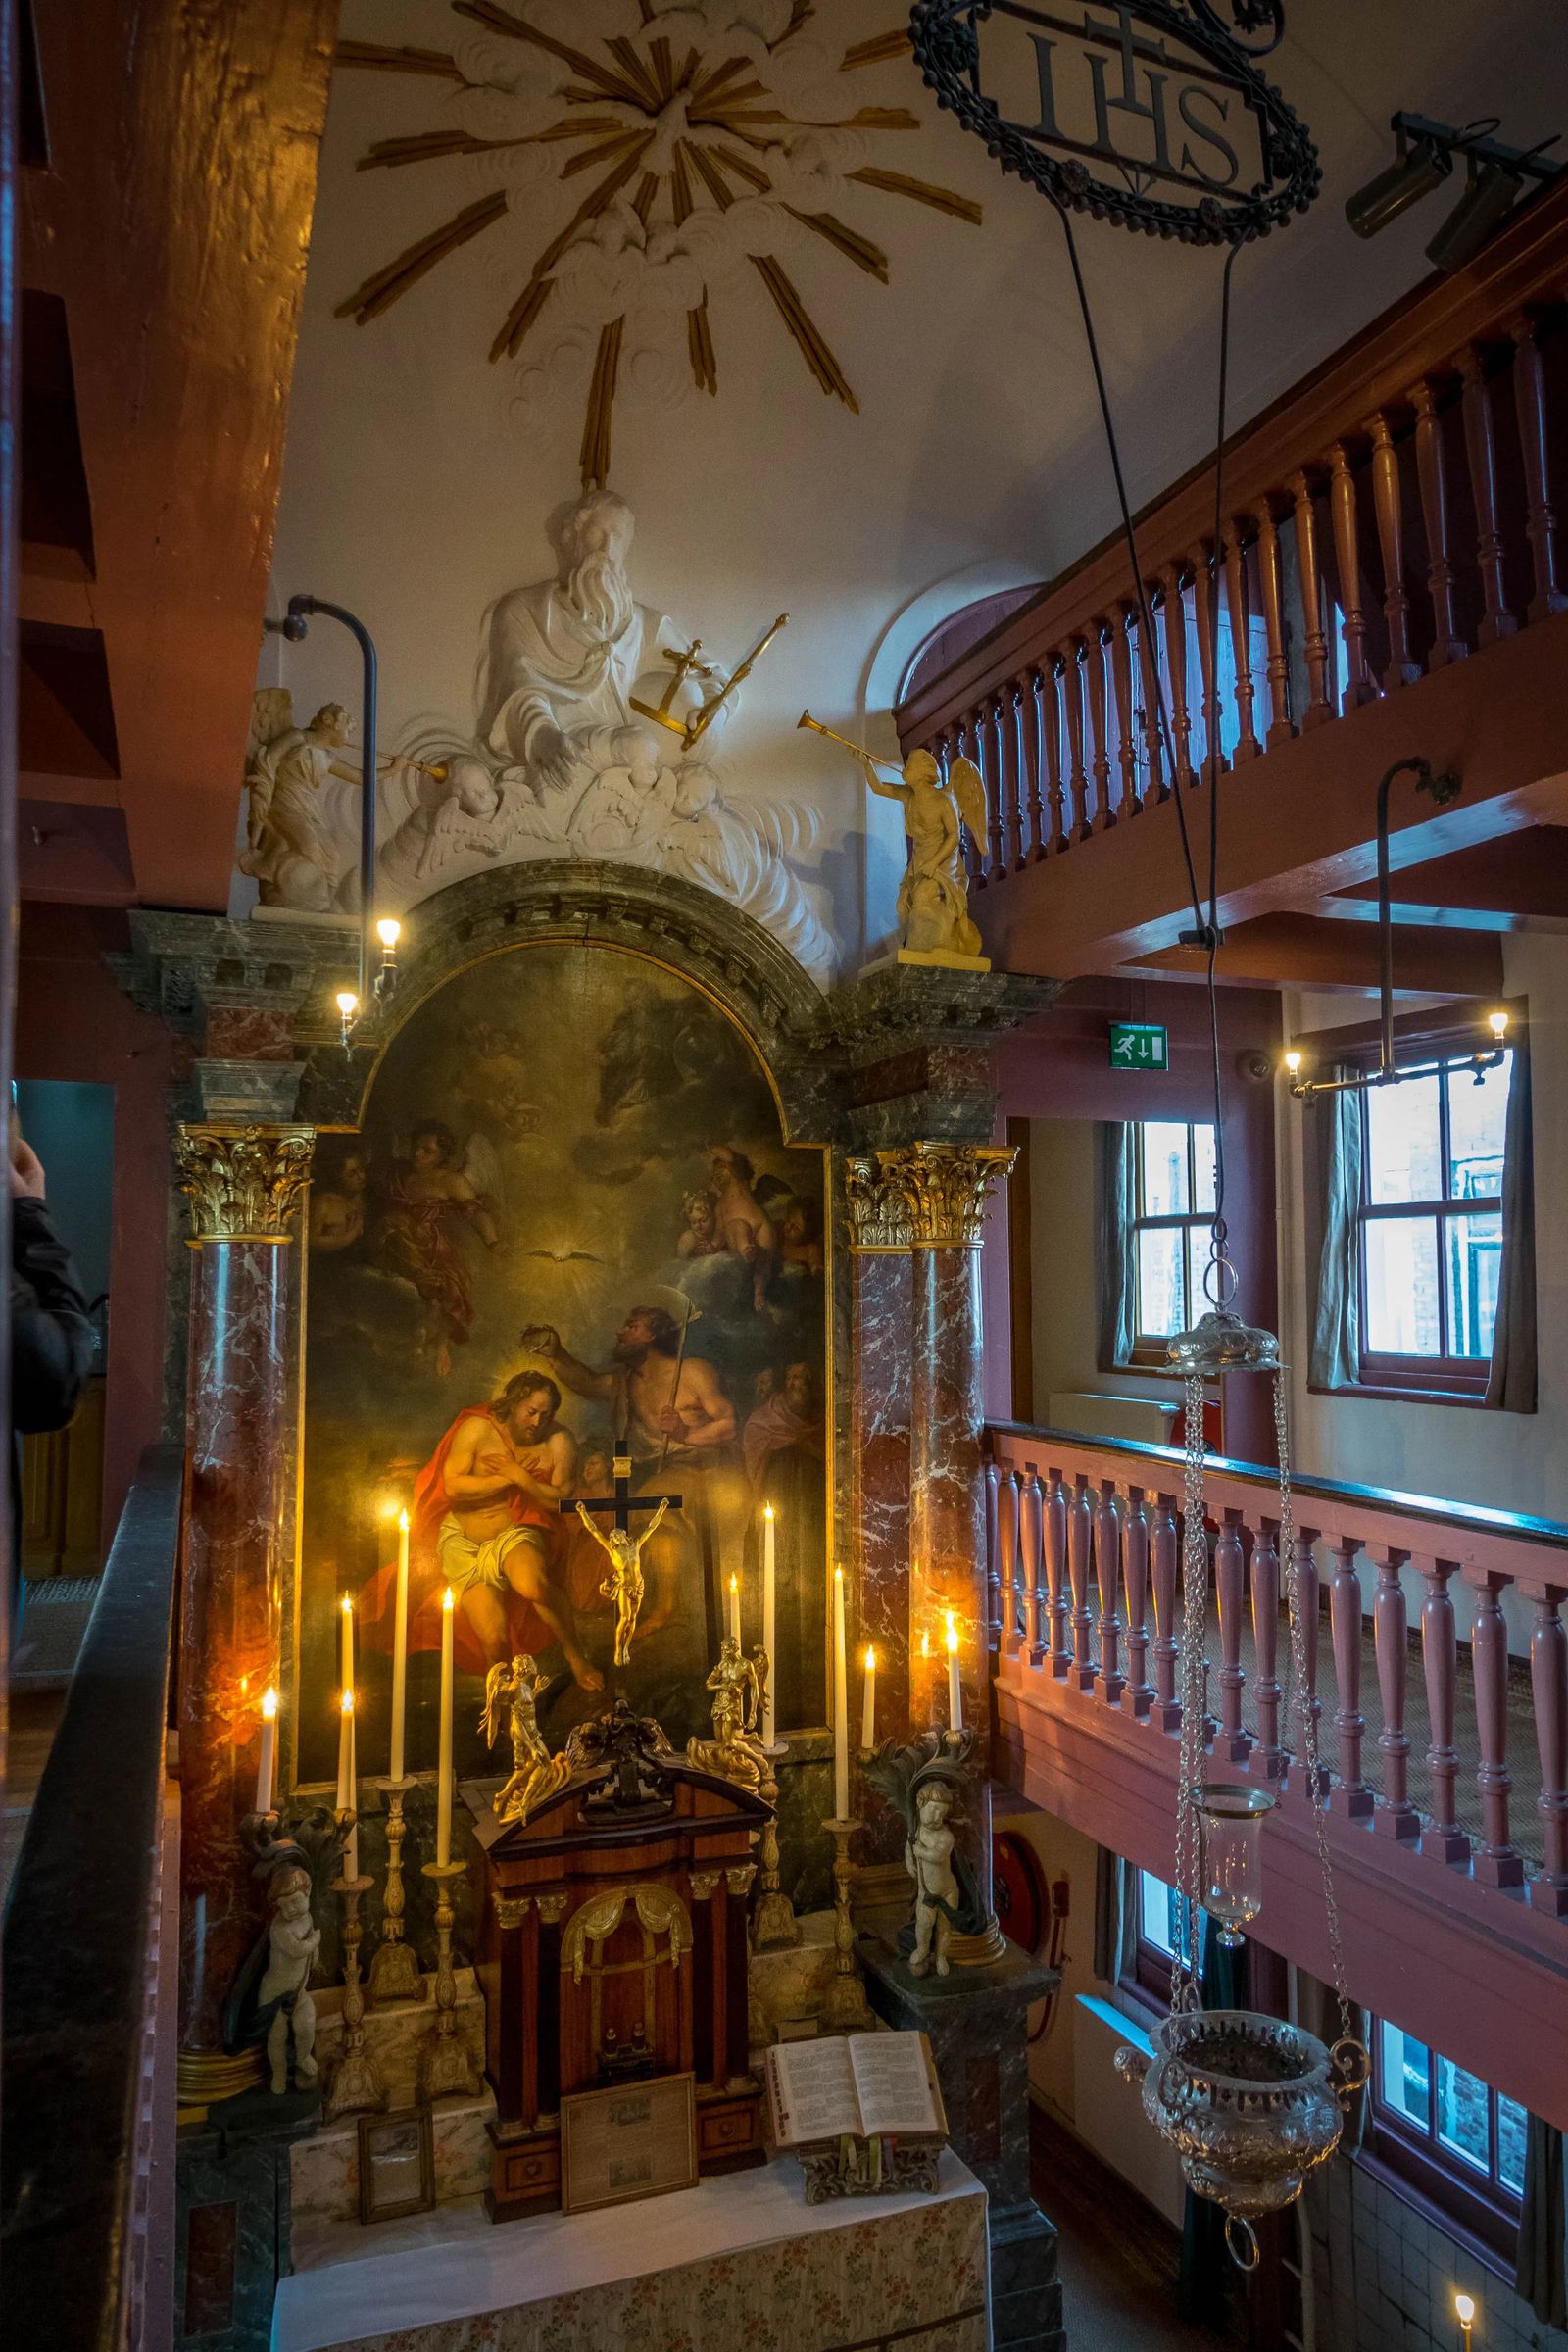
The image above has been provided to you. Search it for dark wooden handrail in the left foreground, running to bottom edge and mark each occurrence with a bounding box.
[0,1446,183,2352]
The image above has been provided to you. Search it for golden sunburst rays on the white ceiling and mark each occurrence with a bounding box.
[336,0,980,487]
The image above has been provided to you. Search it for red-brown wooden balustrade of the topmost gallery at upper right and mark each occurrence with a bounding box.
[896,188,1568,889]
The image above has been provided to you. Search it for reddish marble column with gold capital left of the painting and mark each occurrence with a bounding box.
[174,1119,313,2107]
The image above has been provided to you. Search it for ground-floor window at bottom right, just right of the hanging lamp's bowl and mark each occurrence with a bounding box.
[1363,2018,1528,2265]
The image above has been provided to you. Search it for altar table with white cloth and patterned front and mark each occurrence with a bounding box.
[272,2150,990,2352]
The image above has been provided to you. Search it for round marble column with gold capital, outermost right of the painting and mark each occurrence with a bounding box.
[877,1143,1018,1959]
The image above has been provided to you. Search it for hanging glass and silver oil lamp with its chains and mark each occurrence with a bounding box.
[1116,1279,1371,2270]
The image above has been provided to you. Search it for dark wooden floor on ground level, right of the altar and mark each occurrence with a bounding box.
[1030,2107,1246,2352]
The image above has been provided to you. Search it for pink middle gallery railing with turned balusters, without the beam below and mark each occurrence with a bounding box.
[987,1423,1568,1922]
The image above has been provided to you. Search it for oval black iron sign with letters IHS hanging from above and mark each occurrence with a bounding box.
[909,0,1321,245]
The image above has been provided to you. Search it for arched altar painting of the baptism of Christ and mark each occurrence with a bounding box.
[299,943,827,1781]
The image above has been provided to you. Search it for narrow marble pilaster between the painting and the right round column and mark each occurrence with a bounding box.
[844,1154,912,1872]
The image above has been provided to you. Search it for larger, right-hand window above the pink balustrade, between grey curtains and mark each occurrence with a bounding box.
[1356,1054,1514,1397]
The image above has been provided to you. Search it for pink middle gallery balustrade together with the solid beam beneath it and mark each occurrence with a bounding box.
[987,1425,1568,2127]
